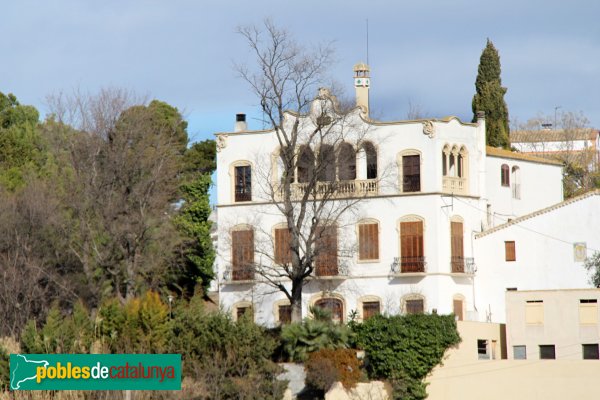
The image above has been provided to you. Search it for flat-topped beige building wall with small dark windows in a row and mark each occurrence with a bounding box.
[506,289,600,360]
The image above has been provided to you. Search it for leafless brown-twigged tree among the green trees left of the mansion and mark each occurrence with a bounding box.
[47,89,187,299]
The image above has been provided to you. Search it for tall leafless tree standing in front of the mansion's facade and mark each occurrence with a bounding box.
[236,20,376,321]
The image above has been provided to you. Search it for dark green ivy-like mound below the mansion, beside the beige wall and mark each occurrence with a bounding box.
[353,314,460,400]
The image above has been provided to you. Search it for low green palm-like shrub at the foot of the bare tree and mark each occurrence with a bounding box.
[281,311,352,361]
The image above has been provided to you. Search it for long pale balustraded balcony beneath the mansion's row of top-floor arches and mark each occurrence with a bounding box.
[277,179,379,200]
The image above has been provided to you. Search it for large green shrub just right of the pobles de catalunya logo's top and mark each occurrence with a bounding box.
[170,296,287,400]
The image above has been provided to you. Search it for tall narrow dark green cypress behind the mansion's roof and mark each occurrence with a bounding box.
[473,39,510,149]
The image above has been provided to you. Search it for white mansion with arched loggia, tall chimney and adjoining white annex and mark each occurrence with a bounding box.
[215,64,600,326]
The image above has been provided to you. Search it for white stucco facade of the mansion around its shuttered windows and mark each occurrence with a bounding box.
[217,95,584,325]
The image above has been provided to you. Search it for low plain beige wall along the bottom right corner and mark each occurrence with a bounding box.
[427,322,600,400]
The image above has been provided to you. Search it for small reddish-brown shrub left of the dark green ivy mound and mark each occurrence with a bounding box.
[304,349,361,391]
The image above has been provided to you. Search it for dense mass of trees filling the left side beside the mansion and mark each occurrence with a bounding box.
[0,89,215,336]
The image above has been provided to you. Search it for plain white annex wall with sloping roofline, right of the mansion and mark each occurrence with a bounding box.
[474,192,600,322]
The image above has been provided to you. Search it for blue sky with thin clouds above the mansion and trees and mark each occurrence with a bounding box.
[0,0,600,140]
